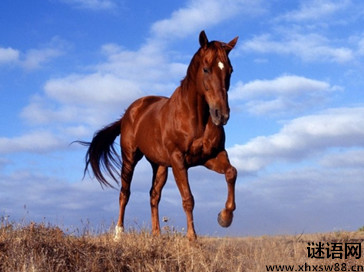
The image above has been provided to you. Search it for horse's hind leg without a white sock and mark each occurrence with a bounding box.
[150,163,168,235]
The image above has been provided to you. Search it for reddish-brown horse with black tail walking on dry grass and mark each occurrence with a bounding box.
[79,31,238,240]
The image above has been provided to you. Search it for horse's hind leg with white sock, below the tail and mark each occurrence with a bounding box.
[114,150,143,241]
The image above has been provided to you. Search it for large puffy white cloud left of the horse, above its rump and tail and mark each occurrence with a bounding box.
[21,73,143,129]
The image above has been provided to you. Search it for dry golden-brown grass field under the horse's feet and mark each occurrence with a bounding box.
[0,222,364,272]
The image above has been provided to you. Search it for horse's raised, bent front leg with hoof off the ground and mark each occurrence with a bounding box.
[205,150,237,228]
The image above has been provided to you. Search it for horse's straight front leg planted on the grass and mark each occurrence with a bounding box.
[171,152,196,241]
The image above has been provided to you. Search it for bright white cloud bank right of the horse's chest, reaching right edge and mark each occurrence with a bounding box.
[228,107,364,172]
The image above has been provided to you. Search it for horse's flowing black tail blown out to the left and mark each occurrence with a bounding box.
[76,120,121,187]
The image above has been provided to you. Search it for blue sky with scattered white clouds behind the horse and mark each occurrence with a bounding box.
[0,0,364,236]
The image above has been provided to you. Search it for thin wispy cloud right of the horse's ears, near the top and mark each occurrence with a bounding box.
[240,32,354,63]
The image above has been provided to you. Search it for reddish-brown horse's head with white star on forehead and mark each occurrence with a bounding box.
[195,31,238,126]
